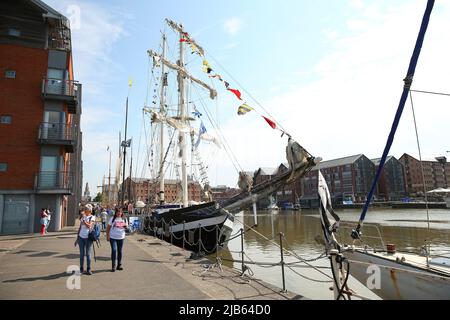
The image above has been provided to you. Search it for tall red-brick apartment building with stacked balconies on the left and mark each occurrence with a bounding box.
[0,0,82,234]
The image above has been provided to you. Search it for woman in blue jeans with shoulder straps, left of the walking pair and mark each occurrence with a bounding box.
[75,204,94,275]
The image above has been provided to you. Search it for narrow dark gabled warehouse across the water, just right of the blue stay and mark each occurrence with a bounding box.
[372,156,407,201]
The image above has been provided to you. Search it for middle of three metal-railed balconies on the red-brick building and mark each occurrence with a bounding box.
[38,122,77,153]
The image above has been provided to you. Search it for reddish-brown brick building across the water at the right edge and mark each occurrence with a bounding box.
[399,153,450,196]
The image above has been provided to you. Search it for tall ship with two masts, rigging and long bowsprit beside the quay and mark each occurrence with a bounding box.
[143,19,320,253]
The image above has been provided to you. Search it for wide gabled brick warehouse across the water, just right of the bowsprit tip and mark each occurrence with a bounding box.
[300,154,375,208]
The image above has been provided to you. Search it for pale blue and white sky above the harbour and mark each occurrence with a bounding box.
[45,0,450,194]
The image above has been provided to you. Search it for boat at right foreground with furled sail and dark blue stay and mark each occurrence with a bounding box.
[318,0,450,300]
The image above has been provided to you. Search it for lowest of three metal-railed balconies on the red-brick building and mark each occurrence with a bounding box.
[34,171,73,195]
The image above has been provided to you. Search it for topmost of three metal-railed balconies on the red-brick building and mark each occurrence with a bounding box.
[42,78,81,114]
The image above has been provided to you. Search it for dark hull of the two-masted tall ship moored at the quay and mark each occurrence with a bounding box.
[144,202,234,253]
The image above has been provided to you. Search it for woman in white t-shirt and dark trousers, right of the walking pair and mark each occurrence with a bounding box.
[106,208,128,272]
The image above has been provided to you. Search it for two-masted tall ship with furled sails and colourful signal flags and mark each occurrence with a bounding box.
[144,19,320,253]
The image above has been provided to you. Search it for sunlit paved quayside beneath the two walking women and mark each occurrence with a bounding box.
[0,228,303,300]
